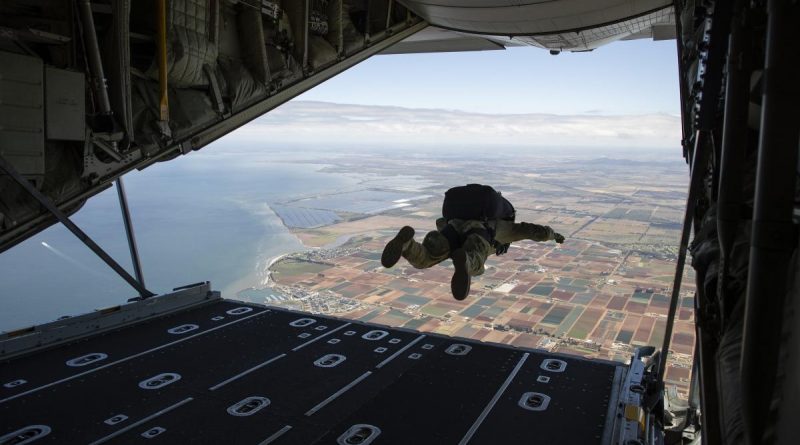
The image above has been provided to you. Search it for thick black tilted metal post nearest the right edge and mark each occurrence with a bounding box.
[741,0,800,443]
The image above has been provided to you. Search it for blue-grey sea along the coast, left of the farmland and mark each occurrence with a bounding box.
[0,144,358,331]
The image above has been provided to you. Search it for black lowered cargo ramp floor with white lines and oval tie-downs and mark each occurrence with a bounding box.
[0,284,641,444]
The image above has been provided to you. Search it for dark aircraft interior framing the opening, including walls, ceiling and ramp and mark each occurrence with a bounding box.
[0,0,800,445]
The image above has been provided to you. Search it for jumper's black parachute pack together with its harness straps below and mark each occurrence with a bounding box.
[441,184,516,255]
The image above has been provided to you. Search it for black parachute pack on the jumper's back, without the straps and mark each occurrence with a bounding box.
[442,184,516,222]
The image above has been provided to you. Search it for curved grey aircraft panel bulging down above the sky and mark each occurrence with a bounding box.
[402,0,672,36]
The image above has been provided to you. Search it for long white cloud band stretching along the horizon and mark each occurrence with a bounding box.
[229,101,680,149]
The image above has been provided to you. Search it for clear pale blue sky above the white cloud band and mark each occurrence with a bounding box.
[295,39,680,116]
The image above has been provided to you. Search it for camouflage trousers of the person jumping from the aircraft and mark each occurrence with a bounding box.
[403,221,494,276]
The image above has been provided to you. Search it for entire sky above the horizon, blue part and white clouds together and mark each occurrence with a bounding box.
[233,40,681,151]
